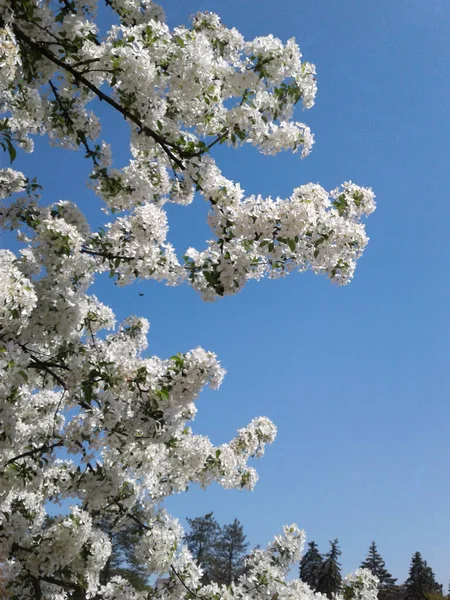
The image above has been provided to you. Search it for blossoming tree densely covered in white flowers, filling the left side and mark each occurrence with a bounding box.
[0,0,376,600]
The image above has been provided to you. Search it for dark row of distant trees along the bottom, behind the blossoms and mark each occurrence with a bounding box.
[81,512,450,600]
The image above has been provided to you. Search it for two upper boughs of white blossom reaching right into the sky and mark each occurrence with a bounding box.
[2,0,374,300]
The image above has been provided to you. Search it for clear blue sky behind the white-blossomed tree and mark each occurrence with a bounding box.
[4,0,450,588]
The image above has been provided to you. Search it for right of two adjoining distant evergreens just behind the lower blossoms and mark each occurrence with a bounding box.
[213,519,248,585]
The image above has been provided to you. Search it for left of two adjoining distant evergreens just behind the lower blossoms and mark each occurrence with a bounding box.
[185,512,220,583]
